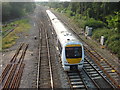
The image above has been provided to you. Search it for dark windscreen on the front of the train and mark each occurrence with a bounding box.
[65,47,82,58]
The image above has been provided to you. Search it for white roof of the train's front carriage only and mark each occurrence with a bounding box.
[52,19,79,46]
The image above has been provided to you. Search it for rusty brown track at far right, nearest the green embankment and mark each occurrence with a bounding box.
[54,13,120,88]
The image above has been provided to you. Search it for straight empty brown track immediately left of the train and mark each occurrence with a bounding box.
[37,12,54,89]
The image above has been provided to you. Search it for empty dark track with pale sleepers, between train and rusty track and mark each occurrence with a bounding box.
[83,57,114,89]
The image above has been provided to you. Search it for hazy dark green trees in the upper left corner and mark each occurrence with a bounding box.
[2,2,35,22]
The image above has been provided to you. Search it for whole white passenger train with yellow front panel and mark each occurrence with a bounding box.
[46,10,84,71]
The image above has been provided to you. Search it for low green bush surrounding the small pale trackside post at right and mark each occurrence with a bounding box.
[92,28,120,57]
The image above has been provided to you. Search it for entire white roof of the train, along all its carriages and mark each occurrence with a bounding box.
[46,11,81,47]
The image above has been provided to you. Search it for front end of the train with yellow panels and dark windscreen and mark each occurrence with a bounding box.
[62,44,84,71]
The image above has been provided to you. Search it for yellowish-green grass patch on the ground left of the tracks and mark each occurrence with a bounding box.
[2,19,31,50]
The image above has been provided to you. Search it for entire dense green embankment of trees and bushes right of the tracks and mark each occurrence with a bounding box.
[43,2,120,58]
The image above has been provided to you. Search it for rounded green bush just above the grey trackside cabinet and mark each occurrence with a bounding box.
[84,18,106,29]
